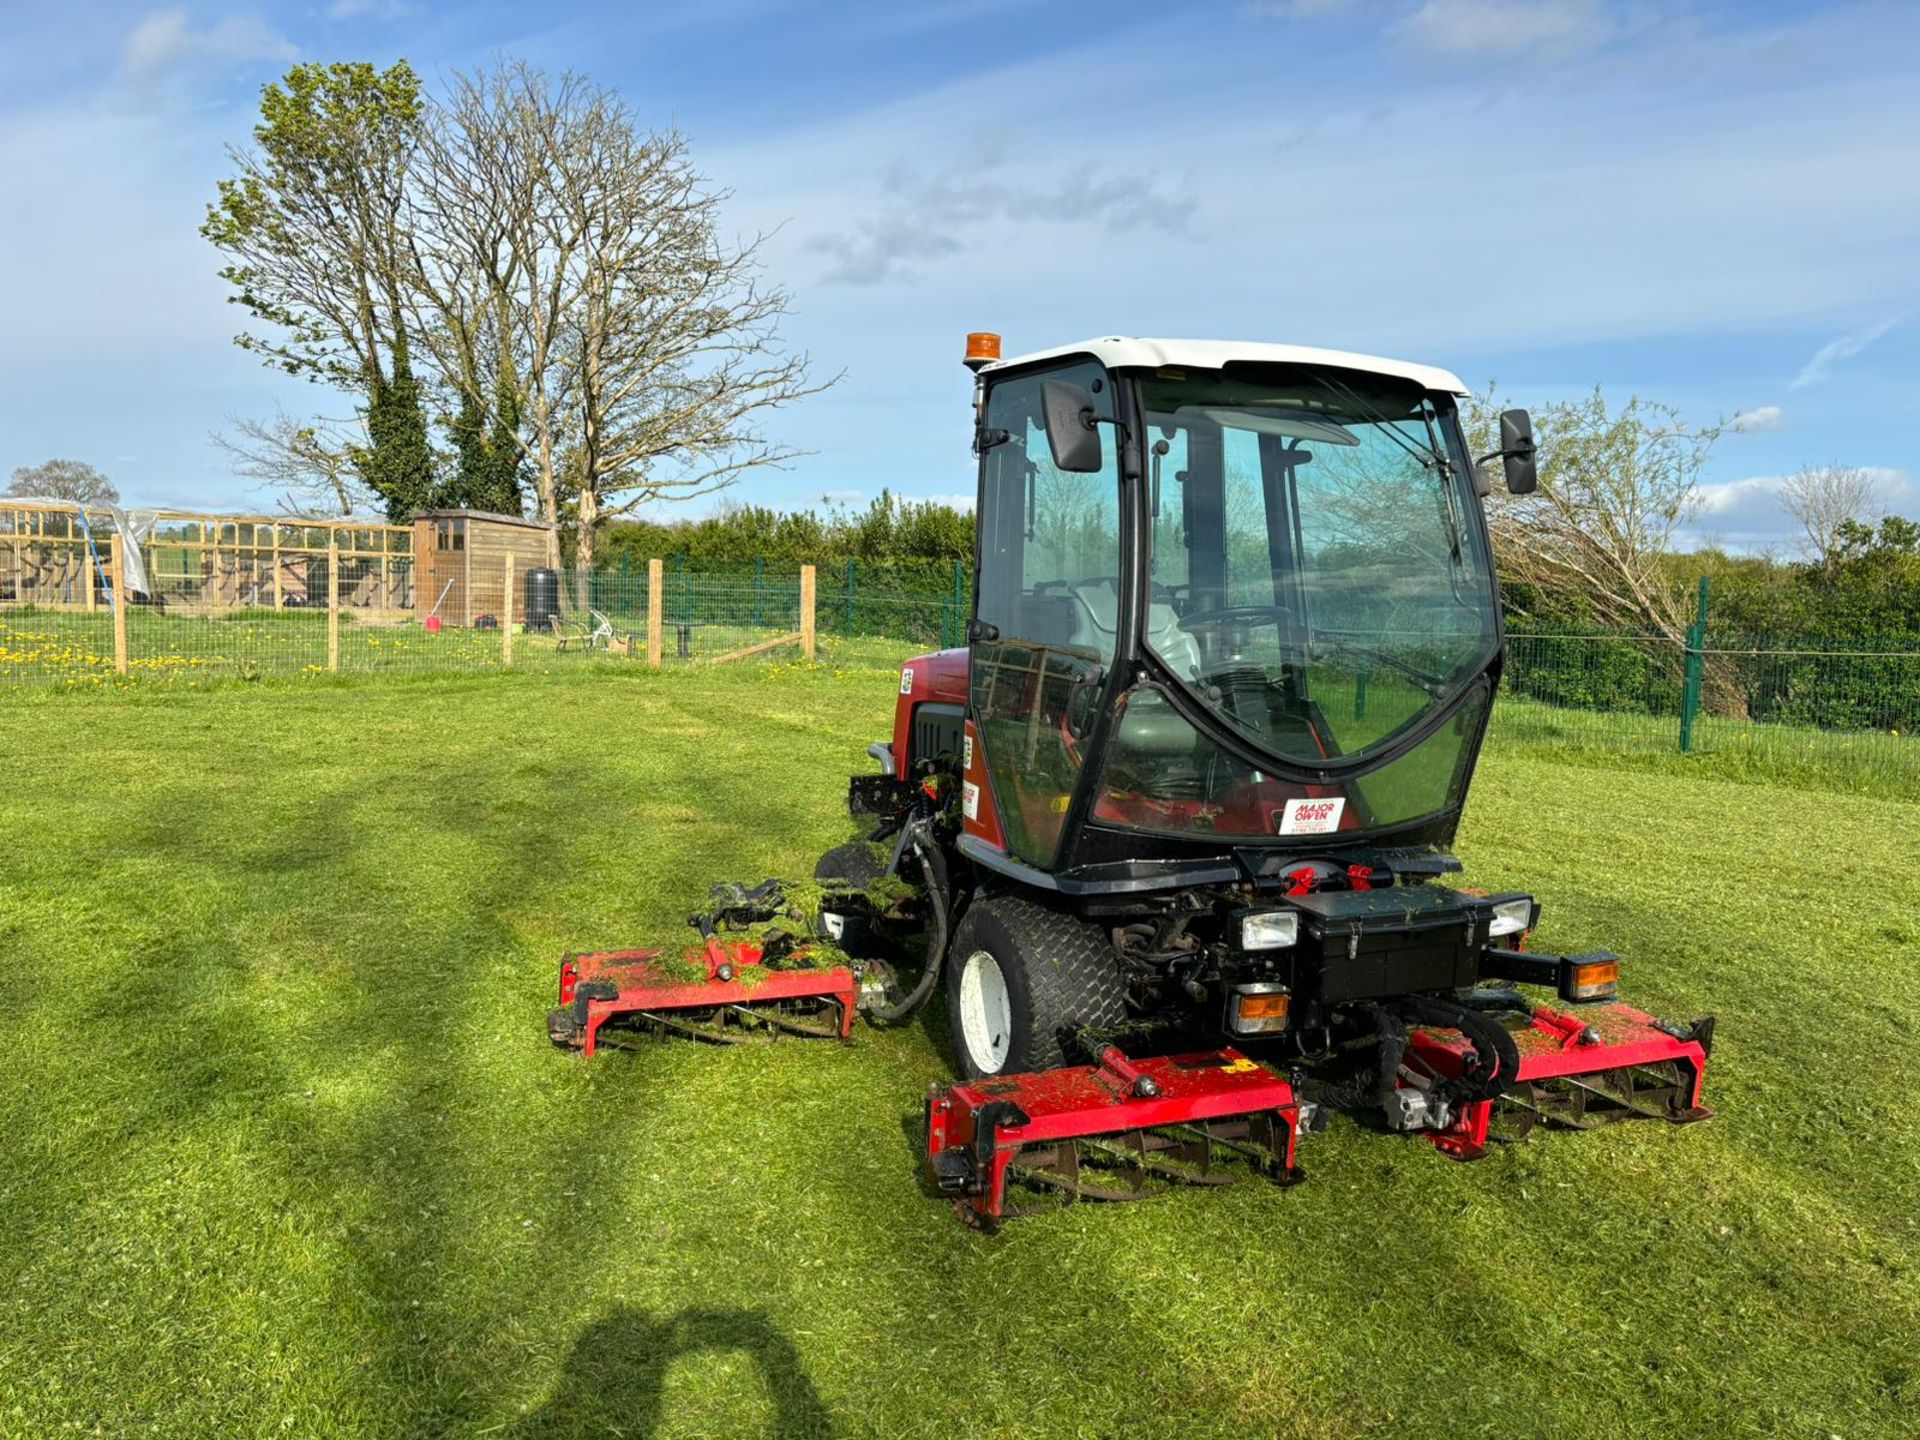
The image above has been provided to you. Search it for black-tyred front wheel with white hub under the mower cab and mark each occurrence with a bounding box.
[947,895,1127,1079]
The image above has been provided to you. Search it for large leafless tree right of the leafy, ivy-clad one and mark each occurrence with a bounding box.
[415,63,824,570]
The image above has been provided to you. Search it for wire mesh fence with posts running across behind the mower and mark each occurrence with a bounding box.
[0,553,1920,795]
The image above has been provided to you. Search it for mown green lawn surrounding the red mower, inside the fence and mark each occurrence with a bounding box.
[0,666,1920,1440]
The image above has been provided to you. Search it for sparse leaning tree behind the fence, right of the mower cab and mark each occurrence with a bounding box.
[1469,388,1720,645]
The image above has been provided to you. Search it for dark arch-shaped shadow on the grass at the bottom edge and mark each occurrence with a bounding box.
[509,1306,833,1440]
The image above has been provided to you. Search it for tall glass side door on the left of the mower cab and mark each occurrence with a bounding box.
[970,361,1121,868]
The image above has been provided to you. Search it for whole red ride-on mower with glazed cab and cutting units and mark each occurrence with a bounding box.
[549,334,1713,1227]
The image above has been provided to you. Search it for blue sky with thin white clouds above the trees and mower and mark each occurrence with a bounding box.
[0,0,1920,545]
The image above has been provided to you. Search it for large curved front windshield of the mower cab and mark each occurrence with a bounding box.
[1140,367,1498,762]
